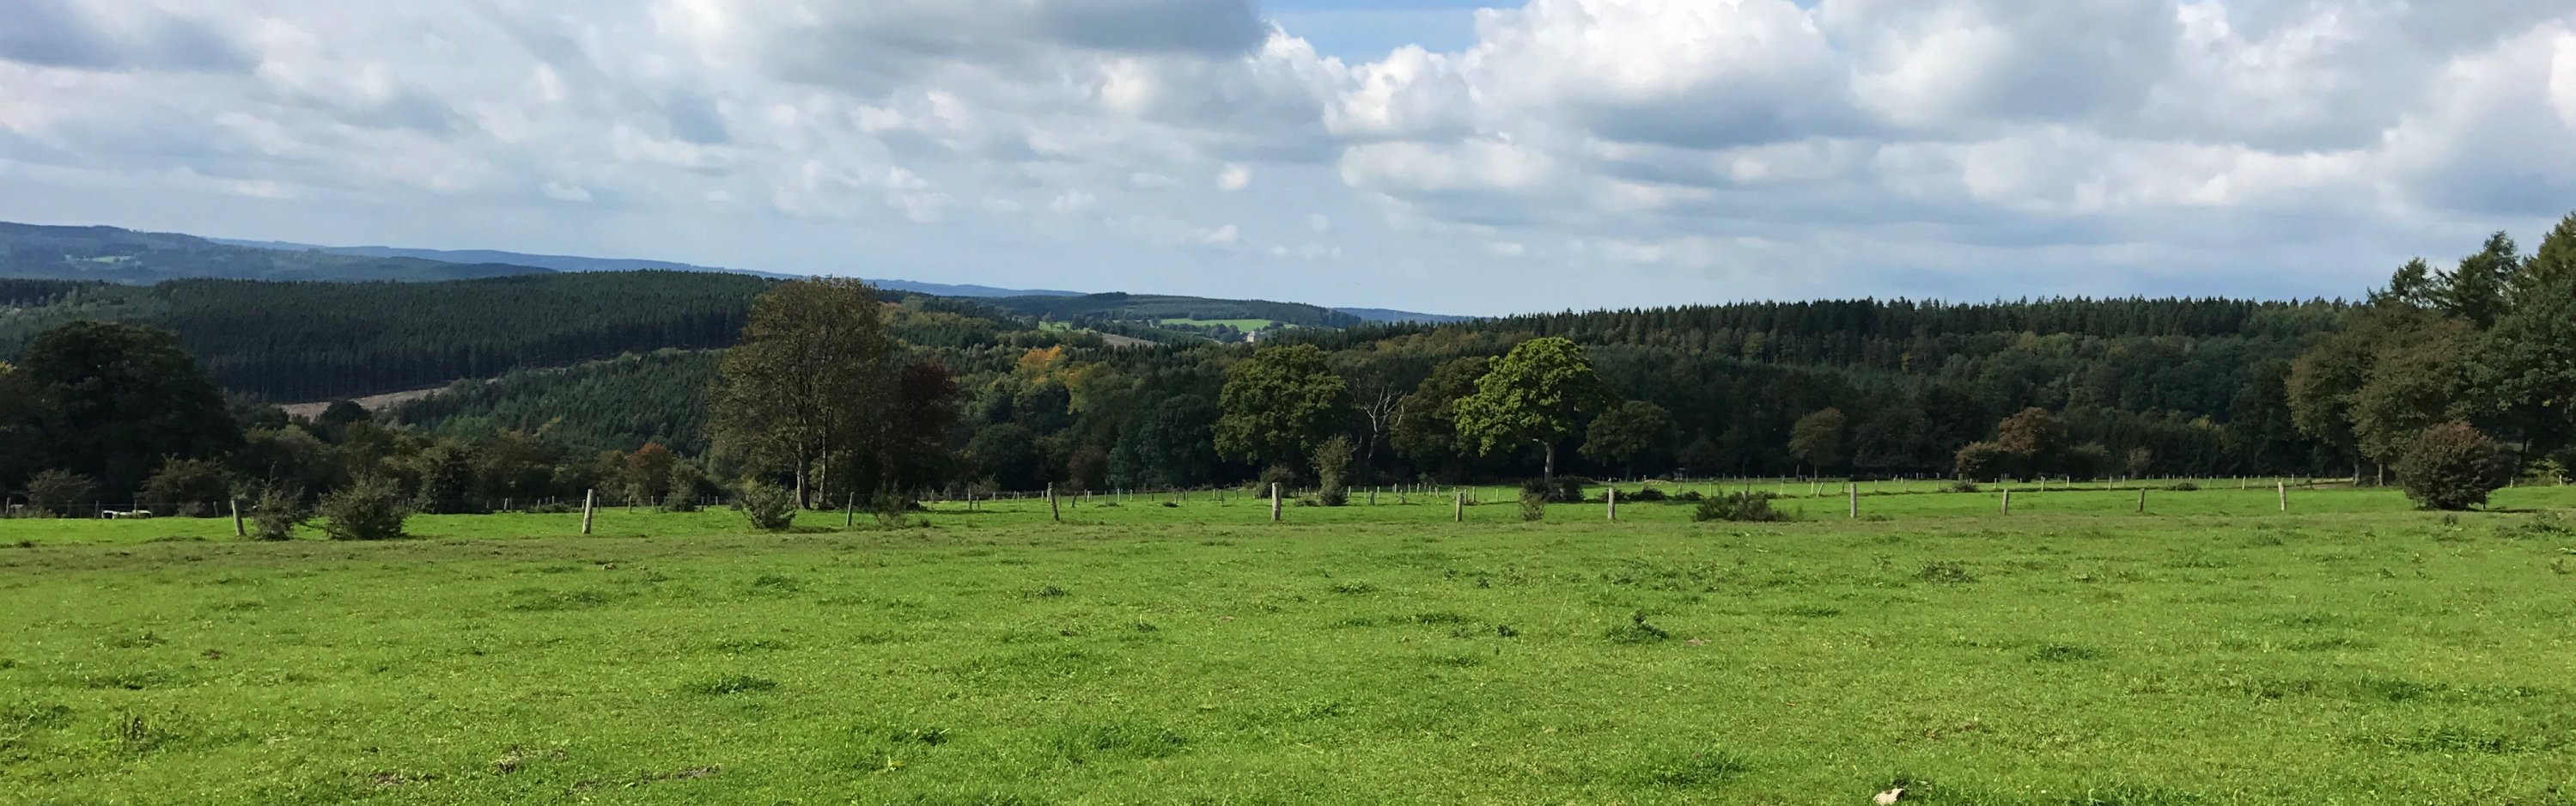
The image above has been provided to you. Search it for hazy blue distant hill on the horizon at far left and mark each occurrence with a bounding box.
[0,222,551,284]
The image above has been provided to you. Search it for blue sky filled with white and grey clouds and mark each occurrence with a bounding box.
[0,0,2576,314]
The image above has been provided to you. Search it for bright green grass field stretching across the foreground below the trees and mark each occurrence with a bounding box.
[0,484,2576,806]
